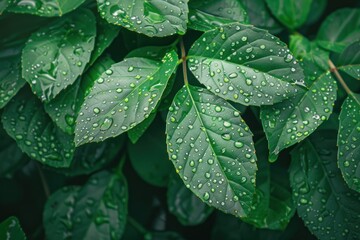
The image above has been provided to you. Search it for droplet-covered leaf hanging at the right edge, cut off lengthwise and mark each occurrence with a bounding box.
[337,94,360,192]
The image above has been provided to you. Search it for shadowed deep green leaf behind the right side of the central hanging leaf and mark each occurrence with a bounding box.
[244,140,296,230]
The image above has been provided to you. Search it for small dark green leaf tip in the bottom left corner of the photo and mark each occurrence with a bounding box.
[0,217,26,240]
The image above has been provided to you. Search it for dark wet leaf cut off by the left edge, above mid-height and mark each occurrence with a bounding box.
[0,40,26,108]
